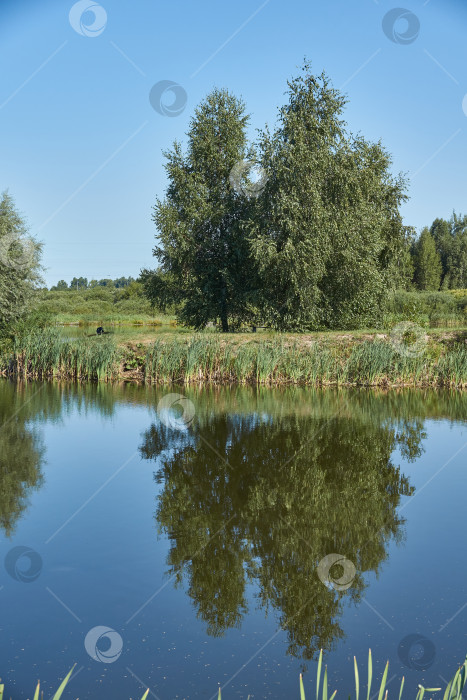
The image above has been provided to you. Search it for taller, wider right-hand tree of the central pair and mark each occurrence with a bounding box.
[251,64,414,330]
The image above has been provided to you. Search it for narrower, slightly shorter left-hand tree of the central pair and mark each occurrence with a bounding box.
[150,89,255,331]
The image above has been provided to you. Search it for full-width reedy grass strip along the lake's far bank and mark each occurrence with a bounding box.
[0,329,467,388]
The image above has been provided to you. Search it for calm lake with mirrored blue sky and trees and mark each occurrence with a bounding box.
[0,380,467,700]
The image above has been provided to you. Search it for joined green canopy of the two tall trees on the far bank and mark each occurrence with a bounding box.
[144,64,409,331]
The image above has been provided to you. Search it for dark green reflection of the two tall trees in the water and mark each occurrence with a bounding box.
[141,411,423,659]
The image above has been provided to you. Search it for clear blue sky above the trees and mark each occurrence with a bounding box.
[0,0,467,284]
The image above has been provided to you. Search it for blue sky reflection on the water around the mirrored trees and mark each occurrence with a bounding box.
[0,385,466,698]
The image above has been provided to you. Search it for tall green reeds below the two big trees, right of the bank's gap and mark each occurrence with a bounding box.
[143,334,467,387]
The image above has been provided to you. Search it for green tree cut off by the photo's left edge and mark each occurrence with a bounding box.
[0,192,41,333]
